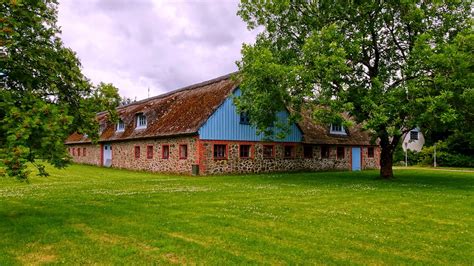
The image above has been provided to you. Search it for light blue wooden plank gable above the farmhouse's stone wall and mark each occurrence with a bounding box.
[199,88,303,142]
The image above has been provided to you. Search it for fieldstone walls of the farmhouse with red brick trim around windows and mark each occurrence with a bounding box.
[69,137,380,175]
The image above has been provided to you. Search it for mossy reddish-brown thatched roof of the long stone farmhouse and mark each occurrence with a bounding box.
[66,74,371,145]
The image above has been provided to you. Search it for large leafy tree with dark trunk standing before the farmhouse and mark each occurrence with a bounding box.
[236,0,472,178]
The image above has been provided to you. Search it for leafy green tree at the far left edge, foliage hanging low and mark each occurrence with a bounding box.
[0,0,118,180]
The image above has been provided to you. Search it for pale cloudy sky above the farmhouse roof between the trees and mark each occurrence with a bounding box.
[59,0,256,100]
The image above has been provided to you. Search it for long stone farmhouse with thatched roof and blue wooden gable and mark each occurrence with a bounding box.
[66,72,380,174]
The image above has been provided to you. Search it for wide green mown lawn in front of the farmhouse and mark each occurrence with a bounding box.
[0,165,474,265]
